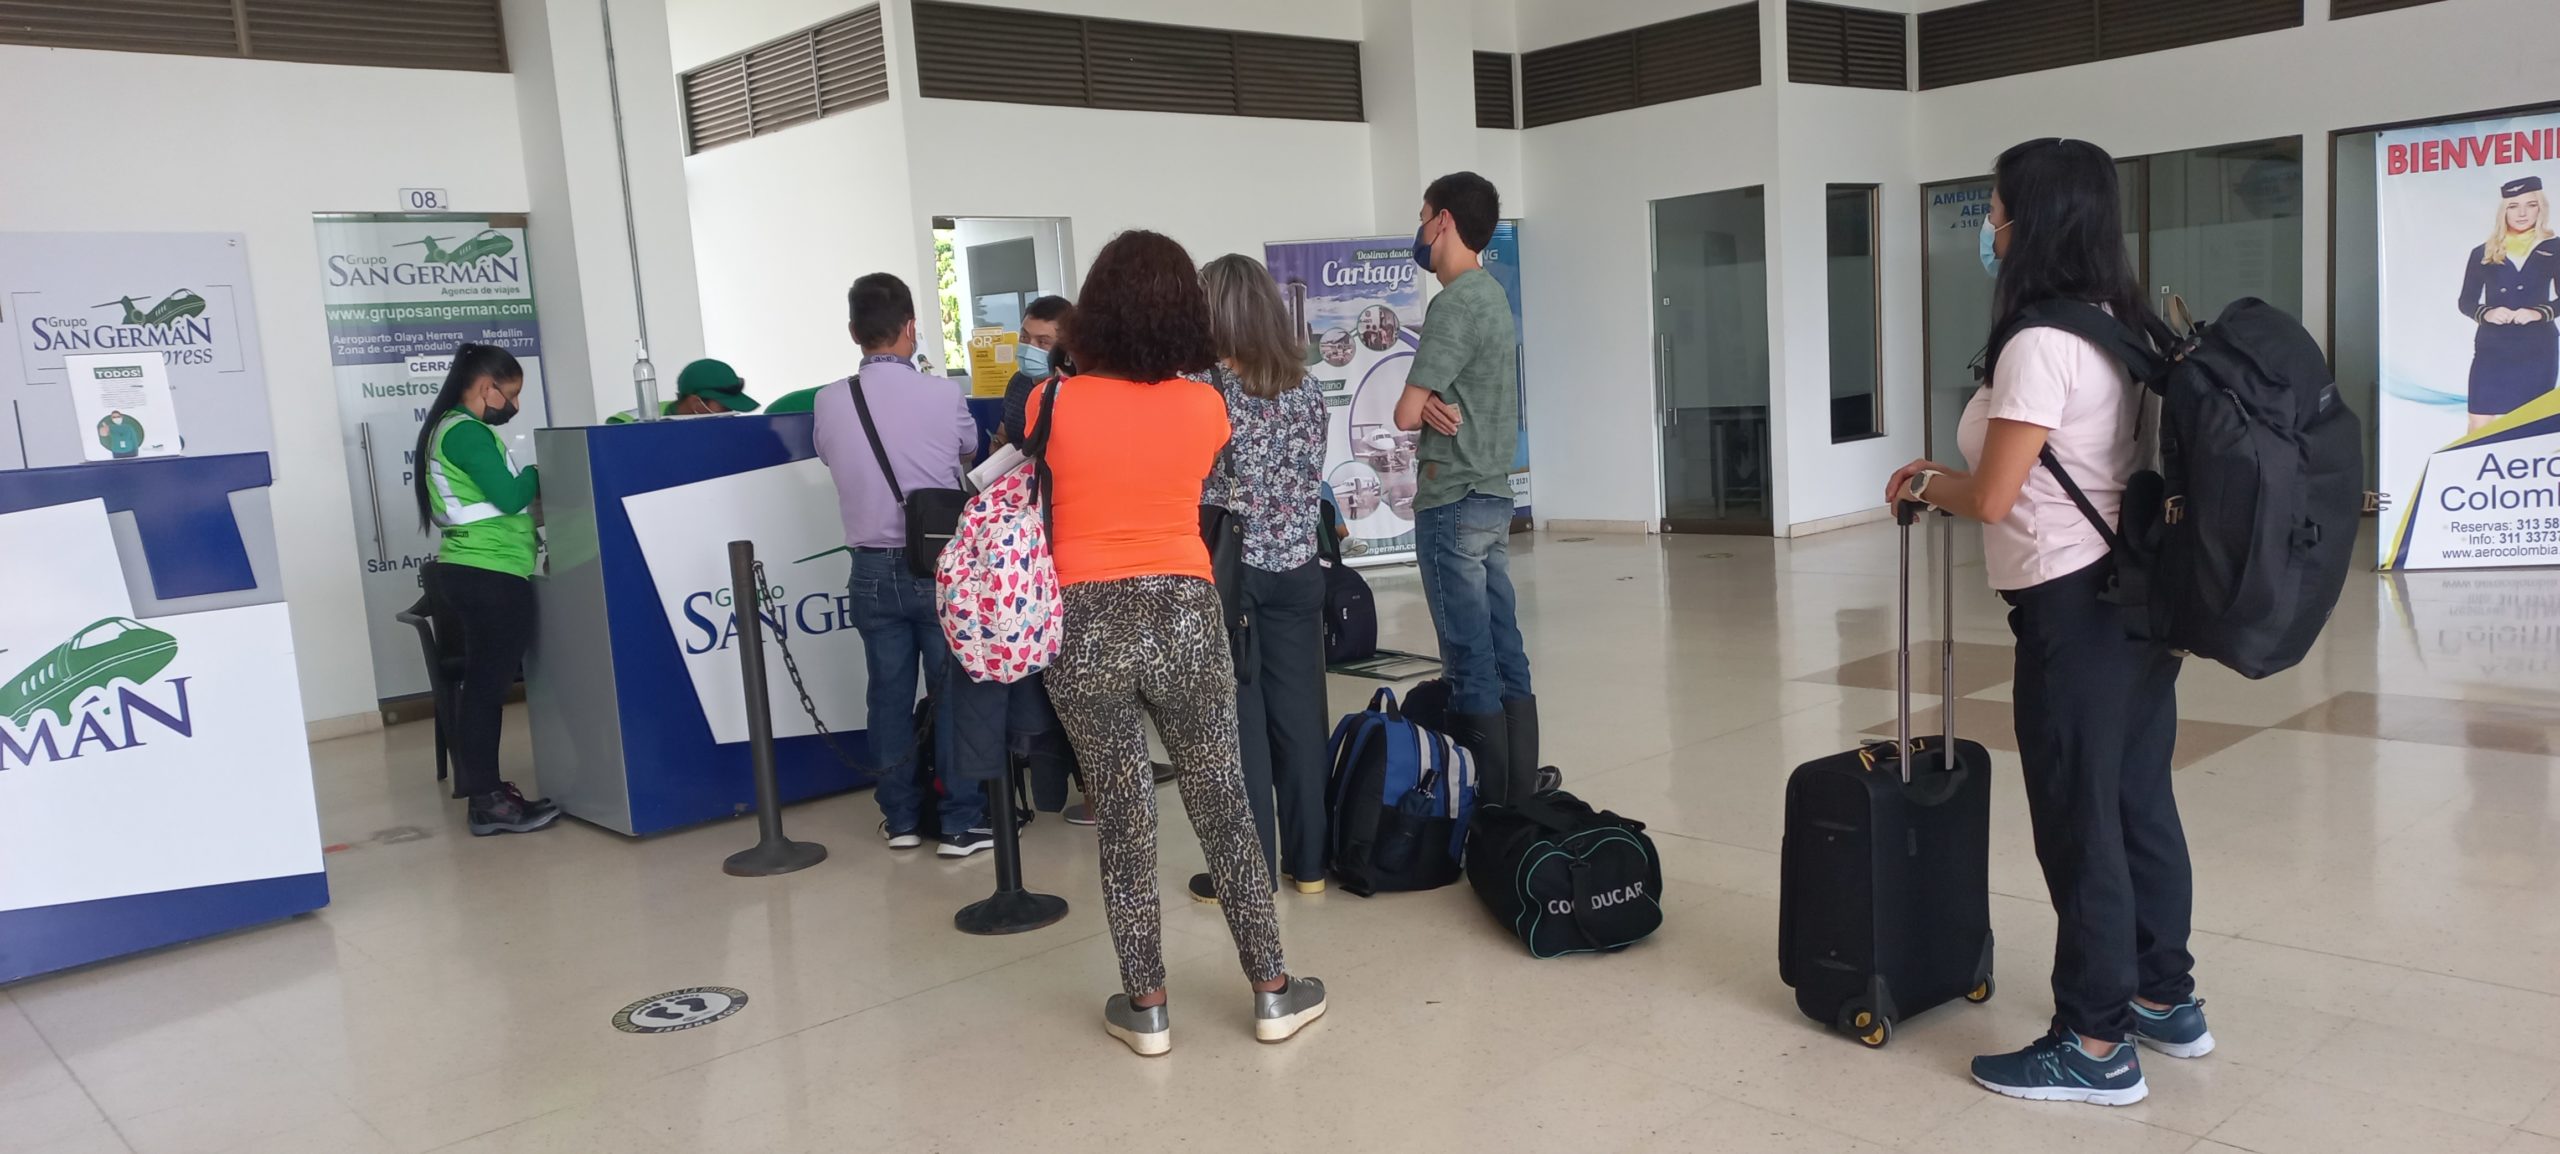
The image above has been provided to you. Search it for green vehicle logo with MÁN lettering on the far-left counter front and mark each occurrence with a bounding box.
[0,617,195,770]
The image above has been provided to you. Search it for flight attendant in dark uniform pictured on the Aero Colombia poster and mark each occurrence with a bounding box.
[2460,177,2560,432]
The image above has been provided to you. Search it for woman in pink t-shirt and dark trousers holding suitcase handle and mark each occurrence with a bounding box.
[1884,138,2214,1105]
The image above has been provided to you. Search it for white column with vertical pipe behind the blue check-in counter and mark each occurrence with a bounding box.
[504,0,701,425]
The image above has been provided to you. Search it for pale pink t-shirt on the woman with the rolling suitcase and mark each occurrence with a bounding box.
[1956,328,2140,591]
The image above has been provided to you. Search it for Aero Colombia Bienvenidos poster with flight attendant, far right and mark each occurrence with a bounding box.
[2376,115,2560,568]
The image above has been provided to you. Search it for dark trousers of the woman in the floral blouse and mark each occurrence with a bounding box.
[1236,560,1331,883]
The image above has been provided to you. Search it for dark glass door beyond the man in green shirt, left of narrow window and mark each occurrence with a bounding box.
[1654,189,1774,535]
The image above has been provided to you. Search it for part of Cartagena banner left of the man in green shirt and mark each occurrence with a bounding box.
[1262,235,1426,558]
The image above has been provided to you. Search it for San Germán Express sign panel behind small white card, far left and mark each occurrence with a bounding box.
[0,233,274,468]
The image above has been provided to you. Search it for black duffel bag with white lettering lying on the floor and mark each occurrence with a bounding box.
[1467,791,1661,957]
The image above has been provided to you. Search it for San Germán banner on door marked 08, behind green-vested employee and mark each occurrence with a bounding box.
[312,212,548,699]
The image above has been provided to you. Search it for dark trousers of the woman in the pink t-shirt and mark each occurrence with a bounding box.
[2002,560,2196,1039]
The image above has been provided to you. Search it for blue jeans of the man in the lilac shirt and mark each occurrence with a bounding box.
[847,550,986,834]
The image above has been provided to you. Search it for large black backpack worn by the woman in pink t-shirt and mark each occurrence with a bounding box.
[2002,297,2371,678]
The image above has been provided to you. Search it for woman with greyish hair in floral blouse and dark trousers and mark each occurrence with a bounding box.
[1190,253,1331,901]
